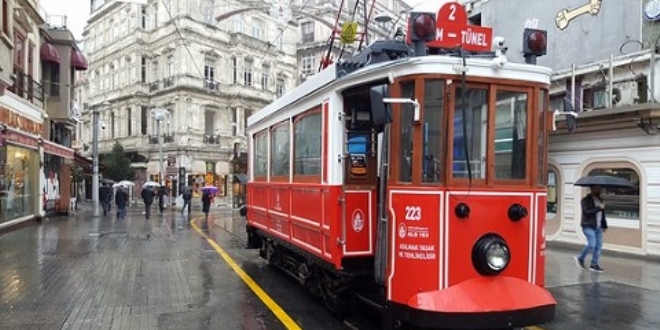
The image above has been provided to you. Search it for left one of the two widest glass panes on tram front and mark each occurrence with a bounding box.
[452,87,488,179]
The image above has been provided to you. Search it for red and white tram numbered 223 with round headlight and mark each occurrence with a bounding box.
[247,3,556,329]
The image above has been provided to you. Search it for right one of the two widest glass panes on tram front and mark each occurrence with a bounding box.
[495,90,528,180]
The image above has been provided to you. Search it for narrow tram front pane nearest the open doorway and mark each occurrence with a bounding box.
[399,81,415,182]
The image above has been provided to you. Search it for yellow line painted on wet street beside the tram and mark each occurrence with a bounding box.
[190,219,302,330]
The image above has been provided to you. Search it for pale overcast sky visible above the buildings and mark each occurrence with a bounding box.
[41,0,438,40]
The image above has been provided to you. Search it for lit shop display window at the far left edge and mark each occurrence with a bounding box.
[0,129,39,224]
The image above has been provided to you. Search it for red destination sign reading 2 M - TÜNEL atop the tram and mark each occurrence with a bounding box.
[427,2,493,52]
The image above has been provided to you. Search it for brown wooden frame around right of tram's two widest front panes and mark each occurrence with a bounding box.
[486,84,535,184]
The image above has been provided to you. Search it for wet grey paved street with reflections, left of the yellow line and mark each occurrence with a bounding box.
[0,213,338,329]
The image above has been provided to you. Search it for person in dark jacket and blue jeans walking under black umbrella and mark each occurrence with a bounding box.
[575,186,607,273]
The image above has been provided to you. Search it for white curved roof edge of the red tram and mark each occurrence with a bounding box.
[248,55,552,126]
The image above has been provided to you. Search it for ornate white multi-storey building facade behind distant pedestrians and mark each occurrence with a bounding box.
[77,0,296,205]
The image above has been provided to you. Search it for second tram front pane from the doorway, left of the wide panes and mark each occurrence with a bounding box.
[422,79,445,183]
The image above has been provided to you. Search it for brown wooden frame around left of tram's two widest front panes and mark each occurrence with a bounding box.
[445,83,494,185]
